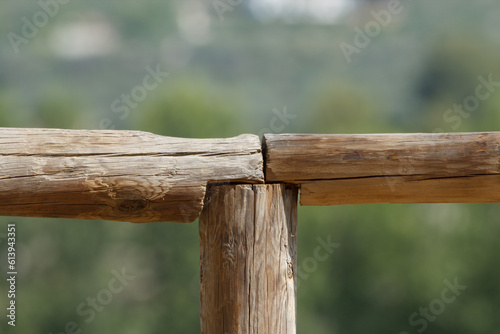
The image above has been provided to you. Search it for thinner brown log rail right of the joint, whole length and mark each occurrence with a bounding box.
[264,132,500,205]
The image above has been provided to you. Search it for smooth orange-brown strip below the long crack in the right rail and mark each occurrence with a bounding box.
[300,175,500,205]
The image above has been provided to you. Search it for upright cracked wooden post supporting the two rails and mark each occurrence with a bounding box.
[200,184,297,334]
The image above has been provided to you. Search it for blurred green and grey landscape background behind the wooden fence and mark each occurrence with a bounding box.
[0,0,500,334]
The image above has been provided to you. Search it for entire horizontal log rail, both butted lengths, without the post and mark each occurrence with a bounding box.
[0,128,500,222]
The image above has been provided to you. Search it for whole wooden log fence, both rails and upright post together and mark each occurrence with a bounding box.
[0,128,500,334]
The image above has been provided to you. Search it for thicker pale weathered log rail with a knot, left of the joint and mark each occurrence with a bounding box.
[0,128,263,222]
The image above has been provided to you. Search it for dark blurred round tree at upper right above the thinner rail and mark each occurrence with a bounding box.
[415,33,500,132]
